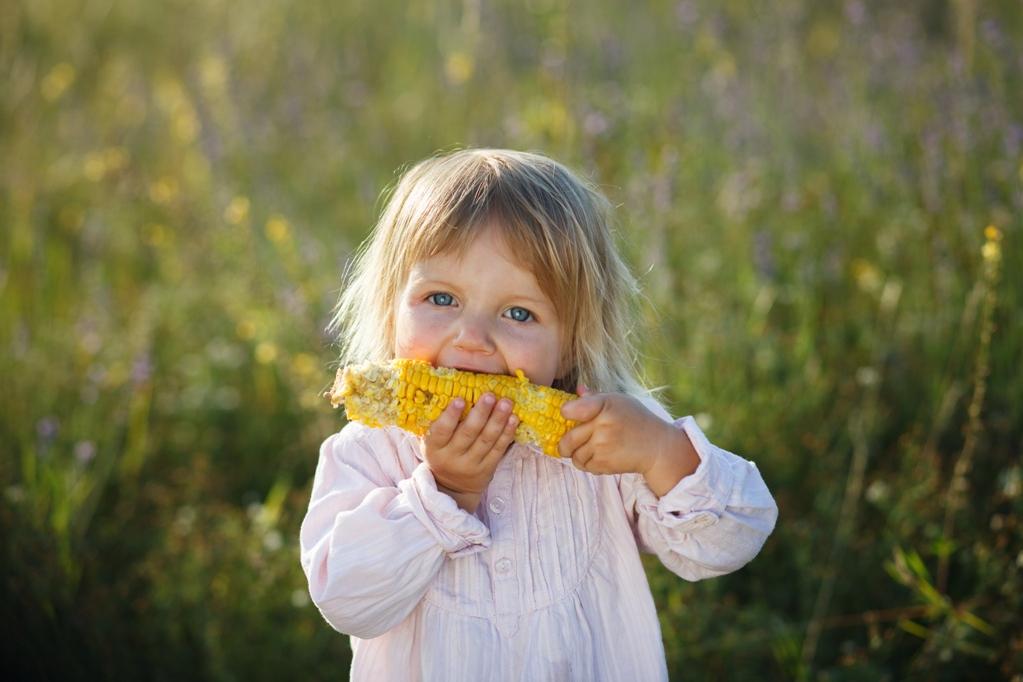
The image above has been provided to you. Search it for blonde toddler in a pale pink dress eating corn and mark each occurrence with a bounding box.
[301,149,777,682]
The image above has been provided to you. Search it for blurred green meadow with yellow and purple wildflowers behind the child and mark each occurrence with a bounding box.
[0,0,1023,680]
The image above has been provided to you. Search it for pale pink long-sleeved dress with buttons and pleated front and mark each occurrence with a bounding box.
[301,409,777,682]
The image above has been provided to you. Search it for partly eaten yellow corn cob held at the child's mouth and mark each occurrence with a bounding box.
[327,360,576,457]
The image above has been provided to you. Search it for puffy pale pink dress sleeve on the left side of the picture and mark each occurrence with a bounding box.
[300,424,490,639]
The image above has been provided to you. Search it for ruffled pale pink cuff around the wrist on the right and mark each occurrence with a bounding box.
[636,417,733,531]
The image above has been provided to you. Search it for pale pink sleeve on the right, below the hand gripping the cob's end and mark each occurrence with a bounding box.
[619,417,777,581]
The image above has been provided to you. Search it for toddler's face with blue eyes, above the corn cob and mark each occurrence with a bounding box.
[395,222,563,385]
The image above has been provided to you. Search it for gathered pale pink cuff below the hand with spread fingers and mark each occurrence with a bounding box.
[398,462,490,556]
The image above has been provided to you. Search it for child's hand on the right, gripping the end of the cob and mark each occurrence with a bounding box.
[558,389,700,496]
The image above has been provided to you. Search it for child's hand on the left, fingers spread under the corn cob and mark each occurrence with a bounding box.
[422,393,519,513]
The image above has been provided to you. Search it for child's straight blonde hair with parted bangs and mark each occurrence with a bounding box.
[328,149,646,395]
